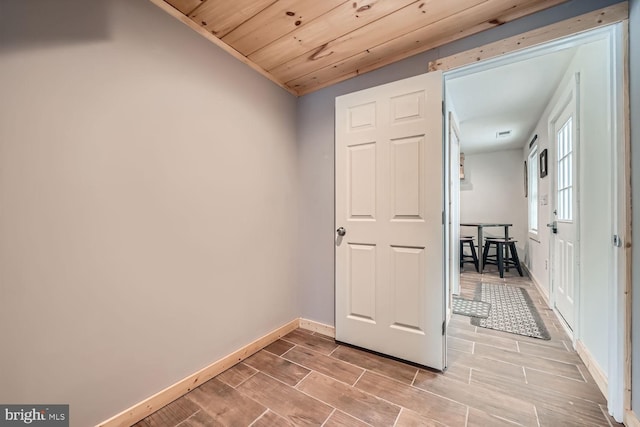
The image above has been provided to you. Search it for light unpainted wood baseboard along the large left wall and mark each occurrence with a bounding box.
[98,319,300,427]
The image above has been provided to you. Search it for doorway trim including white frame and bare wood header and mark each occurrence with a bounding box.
[440,19,637,422]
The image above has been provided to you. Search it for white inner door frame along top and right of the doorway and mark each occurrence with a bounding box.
[443,20,631,421]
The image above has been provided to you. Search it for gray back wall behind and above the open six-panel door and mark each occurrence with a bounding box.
[298,0,619,325]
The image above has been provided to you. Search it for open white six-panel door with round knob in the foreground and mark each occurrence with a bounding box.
[335,72,446,369]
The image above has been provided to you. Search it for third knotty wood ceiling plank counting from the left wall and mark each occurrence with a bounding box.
[224,0,351,55]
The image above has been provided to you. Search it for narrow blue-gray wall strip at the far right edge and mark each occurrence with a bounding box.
[629,0,640,415]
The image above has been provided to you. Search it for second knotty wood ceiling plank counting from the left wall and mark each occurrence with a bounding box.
[189,0,276,38]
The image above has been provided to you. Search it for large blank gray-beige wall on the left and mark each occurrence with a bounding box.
[0,0,300,426]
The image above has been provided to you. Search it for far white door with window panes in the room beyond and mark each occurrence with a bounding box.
[552,88,578,330]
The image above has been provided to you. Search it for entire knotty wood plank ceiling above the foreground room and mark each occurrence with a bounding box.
[151,0,567,95]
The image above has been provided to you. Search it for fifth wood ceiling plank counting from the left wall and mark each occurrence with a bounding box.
[270,0,484,82]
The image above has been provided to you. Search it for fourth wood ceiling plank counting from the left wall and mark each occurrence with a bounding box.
[246,0,417,70]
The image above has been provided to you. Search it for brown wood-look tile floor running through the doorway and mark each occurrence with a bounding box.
[136,272,618,427]
